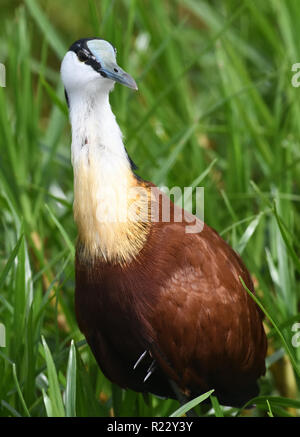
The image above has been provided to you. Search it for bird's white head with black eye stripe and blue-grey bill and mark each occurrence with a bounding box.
[61,38,138,95]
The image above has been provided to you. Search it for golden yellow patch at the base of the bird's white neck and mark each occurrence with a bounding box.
[74,145,151,263]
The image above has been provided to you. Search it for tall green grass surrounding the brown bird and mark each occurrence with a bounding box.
[0,0,300,417]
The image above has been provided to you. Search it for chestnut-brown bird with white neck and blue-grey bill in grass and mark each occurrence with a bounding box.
[60,37,267,407]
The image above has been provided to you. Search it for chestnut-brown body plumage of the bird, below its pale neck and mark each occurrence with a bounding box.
[76,184,267,406]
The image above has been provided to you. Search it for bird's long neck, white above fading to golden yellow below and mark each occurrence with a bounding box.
[69,93,148,263]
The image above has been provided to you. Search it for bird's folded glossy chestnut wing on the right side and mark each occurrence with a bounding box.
[151,223,266,400]
